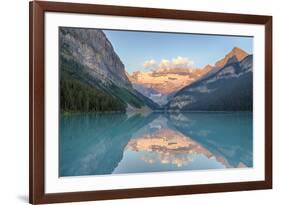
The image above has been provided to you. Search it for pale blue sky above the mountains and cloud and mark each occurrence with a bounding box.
[103,30,253,73]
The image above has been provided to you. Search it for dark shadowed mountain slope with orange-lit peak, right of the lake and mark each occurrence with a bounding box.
[166,48,253,111]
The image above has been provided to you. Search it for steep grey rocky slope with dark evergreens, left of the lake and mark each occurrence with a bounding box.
[59,27,158,111]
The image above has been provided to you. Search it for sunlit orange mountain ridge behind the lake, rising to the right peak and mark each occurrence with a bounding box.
[127,47,248,105]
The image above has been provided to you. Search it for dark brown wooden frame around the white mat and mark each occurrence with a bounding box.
[29,1,272,204]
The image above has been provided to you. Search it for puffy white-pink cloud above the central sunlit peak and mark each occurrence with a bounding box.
[143,56,194,70]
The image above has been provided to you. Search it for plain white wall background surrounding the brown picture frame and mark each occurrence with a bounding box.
[0,0,281,205]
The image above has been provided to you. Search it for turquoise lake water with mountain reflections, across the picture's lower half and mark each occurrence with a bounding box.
[59,112,253,176]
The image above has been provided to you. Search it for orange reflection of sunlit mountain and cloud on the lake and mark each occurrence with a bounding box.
[124,128,212,167]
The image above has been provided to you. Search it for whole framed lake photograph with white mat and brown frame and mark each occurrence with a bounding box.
[30,1,272,204]
